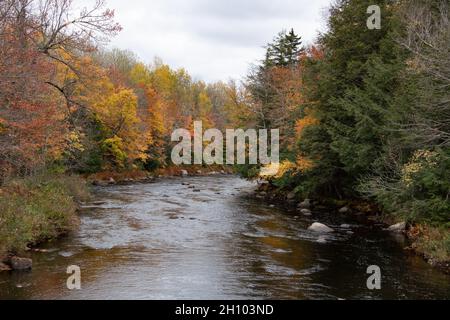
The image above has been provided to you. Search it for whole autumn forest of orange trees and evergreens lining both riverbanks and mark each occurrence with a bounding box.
[0,0,450,270]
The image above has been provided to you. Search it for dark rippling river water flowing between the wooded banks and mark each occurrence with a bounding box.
[0,176,450,299]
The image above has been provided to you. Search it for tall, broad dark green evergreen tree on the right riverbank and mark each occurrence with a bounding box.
[300,0,404,196]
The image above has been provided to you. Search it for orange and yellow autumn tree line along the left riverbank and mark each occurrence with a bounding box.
[0,0,243,179]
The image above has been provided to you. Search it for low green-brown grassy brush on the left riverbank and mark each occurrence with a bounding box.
[0,176,89,257]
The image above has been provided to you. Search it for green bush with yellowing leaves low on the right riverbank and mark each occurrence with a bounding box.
[361,149,450,228]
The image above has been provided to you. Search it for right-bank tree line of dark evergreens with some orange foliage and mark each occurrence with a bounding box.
[246,0,450,227]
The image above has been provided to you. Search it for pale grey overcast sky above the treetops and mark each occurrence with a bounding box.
[89,0,331,82]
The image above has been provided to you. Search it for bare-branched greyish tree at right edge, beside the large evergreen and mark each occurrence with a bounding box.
[400,0,450,146]
